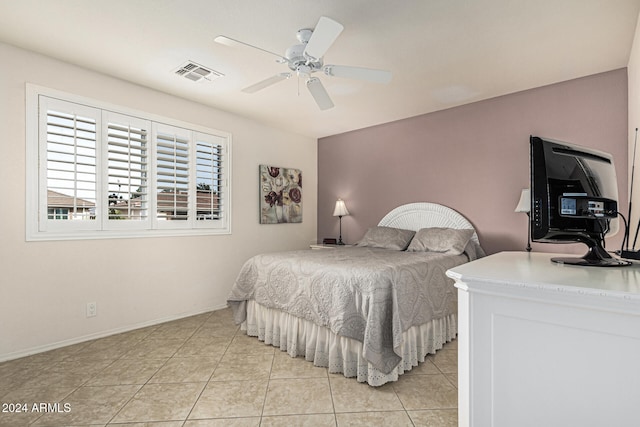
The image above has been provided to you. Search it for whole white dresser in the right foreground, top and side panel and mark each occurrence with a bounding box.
[447,252,640,427]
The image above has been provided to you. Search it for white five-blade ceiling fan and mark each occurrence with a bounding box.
[214,16,392,110]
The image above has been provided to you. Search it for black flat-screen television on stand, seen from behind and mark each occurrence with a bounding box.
[529,136,630,267]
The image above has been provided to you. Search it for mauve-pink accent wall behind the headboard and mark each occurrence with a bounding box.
[318,69,628,253]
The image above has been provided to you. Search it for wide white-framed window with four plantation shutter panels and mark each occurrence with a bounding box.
[27,87,231,240]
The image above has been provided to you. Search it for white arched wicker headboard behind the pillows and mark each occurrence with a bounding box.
[378,202,479,243]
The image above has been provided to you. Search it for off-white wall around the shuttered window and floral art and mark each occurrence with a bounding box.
[0,44,317,361]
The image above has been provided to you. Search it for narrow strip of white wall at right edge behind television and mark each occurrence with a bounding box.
[622,10,640,242]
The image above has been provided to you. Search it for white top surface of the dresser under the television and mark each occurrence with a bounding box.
[447,252,640,299]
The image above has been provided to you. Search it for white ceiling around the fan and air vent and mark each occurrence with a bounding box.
[0,0,640,137]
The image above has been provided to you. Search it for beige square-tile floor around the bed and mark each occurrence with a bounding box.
[0,309,457,427]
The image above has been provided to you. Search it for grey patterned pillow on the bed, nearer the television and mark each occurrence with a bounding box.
[407,227,473,255]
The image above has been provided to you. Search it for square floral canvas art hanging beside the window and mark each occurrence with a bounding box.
[260,165,302,224]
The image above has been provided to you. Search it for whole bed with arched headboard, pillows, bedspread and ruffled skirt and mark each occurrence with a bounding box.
[227,203,484,386]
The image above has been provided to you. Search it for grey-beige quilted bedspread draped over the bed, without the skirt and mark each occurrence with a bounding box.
[228,247,469,373]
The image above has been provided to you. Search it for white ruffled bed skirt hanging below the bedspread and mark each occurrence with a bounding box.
[241,300,458,386]
